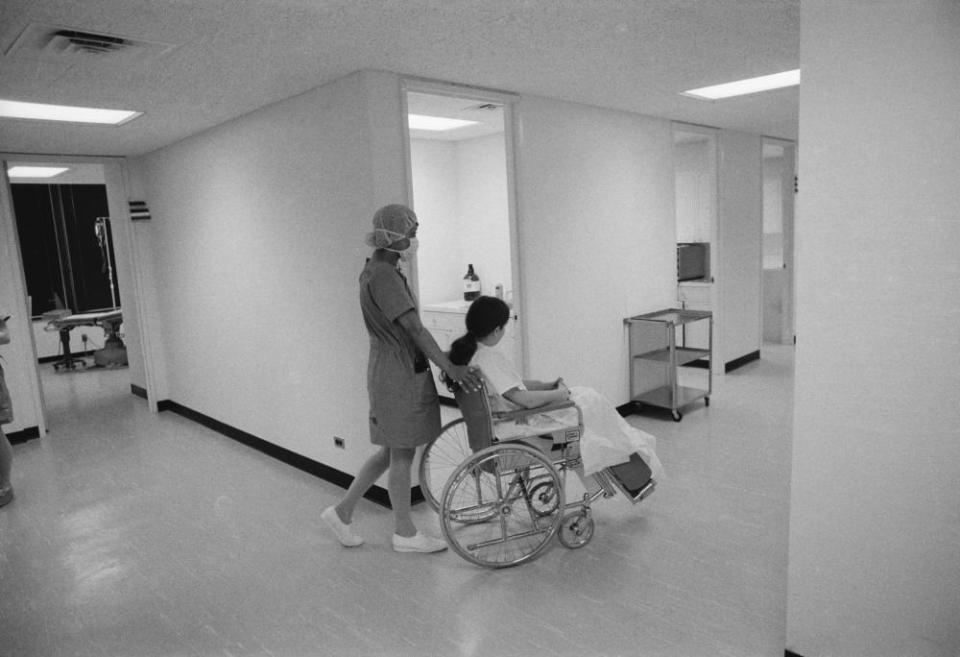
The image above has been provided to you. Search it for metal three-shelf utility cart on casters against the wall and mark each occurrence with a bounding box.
[624,308,713,422]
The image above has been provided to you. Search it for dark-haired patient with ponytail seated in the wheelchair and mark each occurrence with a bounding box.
[450,296,663,483]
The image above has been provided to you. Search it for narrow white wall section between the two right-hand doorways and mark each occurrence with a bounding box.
[712,130,763,363]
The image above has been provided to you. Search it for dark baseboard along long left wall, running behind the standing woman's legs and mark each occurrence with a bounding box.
[157,399,404,509]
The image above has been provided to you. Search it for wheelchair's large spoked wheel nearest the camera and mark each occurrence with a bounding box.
[440,443,563,568]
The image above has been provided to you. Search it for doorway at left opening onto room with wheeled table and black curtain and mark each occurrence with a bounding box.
[4,156,132,435]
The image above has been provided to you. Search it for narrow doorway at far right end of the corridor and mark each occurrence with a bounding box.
[762,138,796,344]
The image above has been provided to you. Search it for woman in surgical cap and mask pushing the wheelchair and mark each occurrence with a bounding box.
[321,205,479,552]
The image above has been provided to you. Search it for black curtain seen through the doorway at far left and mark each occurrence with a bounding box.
[10,183,120,316]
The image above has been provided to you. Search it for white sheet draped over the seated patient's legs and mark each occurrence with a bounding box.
[497,386,663,481]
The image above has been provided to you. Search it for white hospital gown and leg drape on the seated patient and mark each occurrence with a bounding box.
[470,344,663,480]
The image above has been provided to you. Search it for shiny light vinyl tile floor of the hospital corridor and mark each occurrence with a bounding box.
[0,352,793,657]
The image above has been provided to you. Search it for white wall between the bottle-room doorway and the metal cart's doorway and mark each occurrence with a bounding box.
[517,97,677,404]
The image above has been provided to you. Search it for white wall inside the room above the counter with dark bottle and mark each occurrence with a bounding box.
[410,134,511,304]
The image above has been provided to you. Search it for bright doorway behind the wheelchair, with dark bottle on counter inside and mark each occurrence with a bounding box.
[405,83,525,392]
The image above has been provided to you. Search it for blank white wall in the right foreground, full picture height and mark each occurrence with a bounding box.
[787,0,960,657]
